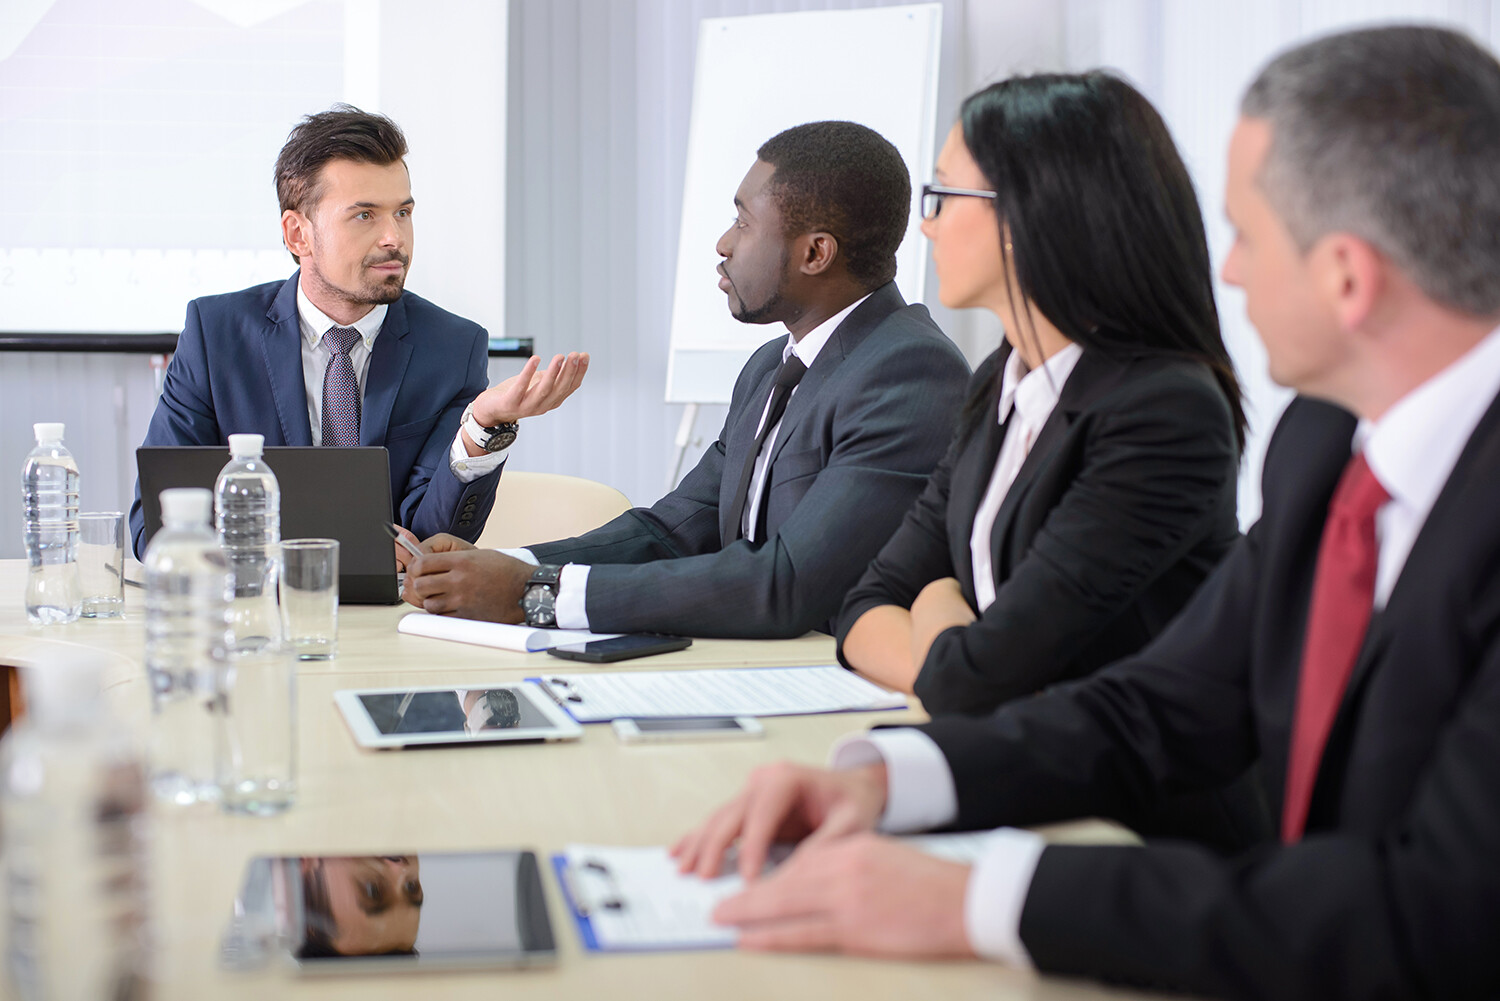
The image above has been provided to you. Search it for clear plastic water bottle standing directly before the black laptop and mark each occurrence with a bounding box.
[213,434,281,597]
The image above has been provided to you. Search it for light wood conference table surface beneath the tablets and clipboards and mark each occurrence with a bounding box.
[0,560,1182,1001]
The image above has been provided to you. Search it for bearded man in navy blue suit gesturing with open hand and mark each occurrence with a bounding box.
[131,105,588,563]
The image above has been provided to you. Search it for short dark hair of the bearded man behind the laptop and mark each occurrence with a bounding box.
[276,104,407,212]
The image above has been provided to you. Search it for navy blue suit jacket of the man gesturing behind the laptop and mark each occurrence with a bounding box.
[131,272,500,557]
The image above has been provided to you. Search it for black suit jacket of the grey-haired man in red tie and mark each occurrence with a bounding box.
[923,399,1500,1001]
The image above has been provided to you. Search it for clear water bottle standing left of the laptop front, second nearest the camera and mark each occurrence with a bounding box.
[146,488,230,806]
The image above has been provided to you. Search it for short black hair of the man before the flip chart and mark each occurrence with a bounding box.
[756,122,912,288]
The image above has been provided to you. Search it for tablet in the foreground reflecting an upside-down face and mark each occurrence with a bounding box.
[225,851,555,972]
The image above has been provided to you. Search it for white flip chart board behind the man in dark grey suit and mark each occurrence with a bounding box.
[666,3,942,404]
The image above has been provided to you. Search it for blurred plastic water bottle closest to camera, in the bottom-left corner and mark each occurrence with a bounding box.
[0,662,150,1001]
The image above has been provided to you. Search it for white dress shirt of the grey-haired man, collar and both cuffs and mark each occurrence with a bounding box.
[831,330,1500,968]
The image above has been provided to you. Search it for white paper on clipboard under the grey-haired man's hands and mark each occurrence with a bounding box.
[563,831,993,950]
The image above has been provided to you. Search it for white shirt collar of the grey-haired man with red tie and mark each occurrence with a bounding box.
[1355,330,1500,512]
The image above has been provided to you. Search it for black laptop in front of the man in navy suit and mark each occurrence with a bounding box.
[135,446,401,605]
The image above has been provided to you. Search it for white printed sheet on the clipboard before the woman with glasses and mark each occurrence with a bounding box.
[540,666,906,723]
